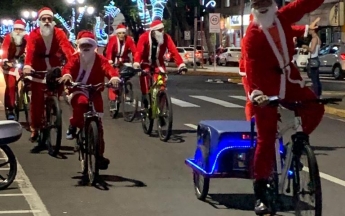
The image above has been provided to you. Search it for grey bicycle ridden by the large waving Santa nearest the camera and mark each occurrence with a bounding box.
[254,96,342,216]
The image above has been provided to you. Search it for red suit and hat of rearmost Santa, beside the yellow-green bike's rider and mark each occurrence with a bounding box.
[106,24,136,101]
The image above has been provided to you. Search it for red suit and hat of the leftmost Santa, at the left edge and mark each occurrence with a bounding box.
[2,20,27,110]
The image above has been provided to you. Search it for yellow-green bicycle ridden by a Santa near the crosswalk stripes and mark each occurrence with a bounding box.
[140,70,173,142]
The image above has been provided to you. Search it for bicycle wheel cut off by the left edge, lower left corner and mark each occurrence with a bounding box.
[0,145,17,190]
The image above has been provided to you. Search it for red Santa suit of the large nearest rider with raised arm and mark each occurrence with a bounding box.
[244,0,324,180]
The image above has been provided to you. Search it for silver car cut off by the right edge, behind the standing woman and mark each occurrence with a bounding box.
[308,43,345,80]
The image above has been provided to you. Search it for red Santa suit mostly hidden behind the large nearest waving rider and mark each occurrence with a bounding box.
[239,20,308,121]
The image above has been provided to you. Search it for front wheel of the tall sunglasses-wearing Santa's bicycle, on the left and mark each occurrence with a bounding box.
[45,96,62,157]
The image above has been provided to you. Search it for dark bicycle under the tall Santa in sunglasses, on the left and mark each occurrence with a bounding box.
[25,67,62,157]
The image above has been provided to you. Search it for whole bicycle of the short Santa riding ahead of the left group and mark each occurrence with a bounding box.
[65,82,112,185]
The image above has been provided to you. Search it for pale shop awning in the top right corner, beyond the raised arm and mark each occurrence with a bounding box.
[296,2,344,26]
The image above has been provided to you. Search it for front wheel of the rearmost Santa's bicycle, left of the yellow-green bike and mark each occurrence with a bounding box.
[122,81,138,122]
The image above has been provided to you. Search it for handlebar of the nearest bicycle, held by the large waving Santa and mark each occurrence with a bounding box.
[253,96,343,106]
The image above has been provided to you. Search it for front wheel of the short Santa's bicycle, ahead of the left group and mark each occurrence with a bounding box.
[84,120,100,185]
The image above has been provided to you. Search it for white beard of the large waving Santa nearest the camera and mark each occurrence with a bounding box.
[252,2,278,28]
